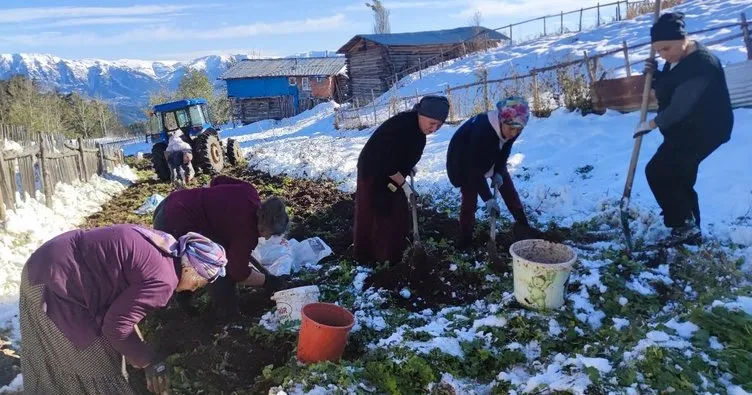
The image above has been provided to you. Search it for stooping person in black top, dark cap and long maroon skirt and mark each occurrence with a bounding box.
[353,96,449,264]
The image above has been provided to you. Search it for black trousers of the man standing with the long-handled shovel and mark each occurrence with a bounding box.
[645,138,720,228]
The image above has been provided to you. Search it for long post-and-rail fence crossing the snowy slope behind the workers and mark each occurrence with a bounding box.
[335,14,752,129]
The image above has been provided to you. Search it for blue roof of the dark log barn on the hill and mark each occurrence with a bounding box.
[337,26,509,53]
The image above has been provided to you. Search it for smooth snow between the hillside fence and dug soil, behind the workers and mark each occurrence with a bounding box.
[223,104,752,245]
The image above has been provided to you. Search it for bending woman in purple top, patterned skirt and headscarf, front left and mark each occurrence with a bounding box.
[19,225,227,395]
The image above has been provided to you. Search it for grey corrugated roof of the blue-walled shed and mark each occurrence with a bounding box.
[219,56,345,80]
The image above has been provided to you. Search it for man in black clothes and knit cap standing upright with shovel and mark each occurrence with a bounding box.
[634,13,734,244]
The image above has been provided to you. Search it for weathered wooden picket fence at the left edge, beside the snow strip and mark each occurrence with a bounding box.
[0,125,128,220]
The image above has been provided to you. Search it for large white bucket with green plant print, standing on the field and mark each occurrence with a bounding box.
[509,239,577,310]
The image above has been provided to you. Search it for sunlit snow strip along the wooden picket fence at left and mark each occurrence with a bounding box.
[0,166,136,341]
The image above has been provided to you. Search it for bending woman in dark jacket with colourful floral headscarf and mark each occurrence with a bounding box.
[446,96,540,248]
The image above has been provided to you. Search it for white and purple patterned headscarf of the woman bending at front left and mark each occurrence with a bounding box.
[133,226,227,282]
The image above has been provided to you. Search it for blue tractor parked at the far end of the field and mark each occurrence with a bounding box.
[149,98,242,181]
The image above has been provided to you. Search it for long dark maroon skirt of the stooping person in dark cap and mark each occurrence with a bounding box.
[354,177,410,265]
